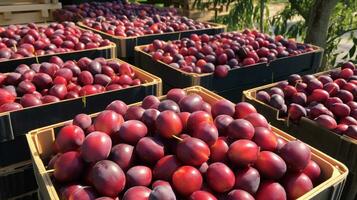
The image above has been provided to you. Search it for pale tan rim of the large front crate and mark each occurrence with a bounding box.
[26,86,349,200]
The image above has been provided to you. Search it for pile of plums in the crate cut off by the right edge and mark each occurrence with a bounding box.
[256,62,357,139]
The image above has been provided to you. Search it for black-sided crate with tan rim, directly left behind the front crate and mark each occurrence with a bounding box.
[0,58,161,142]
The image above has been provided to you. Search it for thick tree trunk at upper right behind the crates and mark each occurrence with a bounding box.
[305,0,338,48]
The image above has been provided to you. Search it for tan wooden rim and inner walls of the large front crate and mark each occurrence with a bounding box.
[26,86,348,200]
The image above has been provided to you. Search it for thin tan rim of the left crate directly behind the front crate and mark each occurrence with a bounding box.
[0,58,162,117]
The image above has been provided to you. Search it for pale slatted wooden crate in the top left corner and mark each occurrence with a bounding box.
[0,0,62,25]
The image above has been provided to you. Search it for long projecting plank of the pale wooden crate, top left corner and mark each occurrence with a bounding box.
[0,3,62,12]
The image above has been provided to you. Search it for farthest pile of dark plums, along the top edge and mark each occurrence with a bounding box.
[53,1,177,21]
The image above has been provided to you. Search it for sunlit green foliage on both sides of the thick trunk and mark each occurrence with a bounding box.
[198,0,357,70]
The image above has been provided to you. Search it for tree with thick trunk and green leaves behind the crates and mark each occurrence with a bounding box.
[196,0,357,69]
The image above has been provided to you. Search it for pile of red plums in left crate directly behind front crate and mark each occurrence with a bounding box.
[0,56,141,112]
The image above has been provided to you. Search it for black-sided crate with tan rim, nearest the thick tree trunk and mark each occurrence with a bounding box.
[135,43,323,102]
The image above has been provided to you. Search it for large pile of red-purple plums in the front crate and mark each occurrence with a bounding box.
[47,89,322,200]
